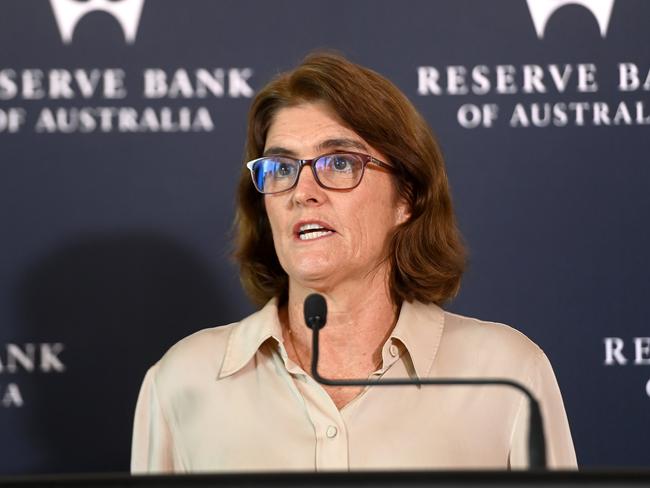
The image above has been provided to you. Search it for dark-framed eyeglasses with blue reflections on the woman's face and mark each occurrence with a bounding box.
[246,152,394,195]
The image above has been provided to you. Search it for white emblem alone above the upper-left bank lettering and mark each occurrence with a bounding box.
[50,0,144,44]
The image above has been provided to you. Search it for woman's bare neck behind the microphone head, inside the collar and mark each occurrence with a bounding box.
[280,266,398,378]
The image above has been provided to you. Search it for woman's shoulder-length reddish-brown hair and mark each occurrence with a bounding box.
[234,53,465,305]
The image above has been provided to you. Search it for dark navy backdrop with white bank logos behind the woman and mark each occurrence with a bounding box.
[0,0,650,474]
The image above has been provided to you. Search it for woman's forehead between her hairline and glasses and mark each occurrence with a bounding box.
[264,102,368,156]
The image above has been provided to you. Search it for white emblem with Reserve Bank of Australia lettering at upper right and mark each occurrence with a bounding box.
[417,0,650,129]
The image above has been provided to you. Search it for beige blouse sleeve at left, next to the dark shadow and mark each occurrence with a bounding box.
[131,365,174,474]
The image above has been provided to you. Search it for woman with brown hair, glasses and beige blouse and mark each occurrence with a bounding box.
[132,54,576,472]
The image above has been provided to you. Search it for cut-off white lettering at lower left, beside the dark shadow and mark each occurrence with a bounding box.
[0,342,65,408]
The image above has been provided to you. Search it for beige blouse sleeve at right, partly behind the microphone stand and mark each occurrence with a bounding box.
[510,351,578,469]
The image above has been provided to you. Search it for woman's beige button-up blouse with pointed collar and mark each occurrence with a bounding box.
[131,300,576,473]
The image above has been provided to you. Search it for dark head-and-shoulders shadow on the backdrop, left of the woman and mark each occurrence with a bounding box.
[14,232,237,473]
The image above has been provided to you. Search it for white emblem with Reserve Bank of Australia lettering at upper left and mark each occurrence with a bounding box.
[0,0,254,134]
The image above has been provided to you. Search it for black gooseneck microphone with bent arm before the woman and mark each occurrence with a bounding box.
[303,293,546,470]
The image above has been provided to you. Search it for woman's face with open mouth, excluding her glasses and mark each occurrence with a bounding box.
[264,103,407,291]
